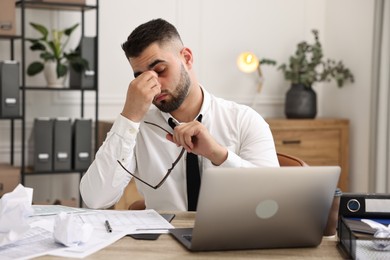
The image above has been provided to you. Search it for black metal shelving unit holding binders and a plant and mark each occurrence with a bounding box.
[0,0,99,205]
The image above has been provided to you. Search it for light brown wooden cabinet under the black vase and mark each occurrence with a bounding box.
[266,118,349,192]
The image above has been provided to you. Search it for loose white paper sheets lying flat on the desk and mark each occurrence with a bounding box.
[0,205,174,259]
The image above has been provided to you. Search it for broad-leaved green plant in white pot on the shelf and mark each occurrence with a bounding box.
[27,23,88,87]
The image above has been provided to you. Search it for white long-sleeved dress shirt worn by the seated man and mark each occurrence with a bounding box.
[80,88,279,211]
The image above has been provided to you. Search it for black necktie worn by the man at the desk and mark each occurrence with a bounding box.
[168,114,202,211]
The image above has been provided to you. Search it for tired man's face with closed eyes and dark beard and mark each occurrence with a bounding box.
[129,44,191,112]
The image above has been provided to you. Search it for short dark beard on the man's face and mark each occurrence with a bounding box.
[153,64,191,113]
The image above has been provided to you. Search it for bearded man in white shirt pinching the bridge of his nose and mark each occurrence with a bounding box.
[80,19,279,210]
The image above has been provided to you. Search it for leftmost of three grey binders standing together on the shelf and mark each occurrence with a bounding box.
[34,118,53,172]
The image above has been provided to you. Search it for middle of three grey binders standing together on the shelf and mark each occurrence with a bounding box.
[53,118,72,171]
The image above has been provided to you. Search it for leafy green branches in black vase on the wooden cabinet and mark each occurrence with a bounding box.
[278,30,354,118]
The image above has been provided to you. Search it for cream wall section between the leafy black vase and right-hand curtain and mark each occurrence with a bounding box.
[322,0,375,192]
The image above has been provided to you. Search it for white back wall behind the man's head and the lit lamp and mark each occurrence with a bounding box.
[100,0,325,118]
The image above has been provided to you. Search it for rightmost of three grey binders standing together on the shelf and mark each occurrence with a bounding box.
[73,119,92,171]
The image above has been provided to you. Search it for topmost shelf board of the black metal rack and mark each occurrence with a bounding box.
[15,1,97,11]
